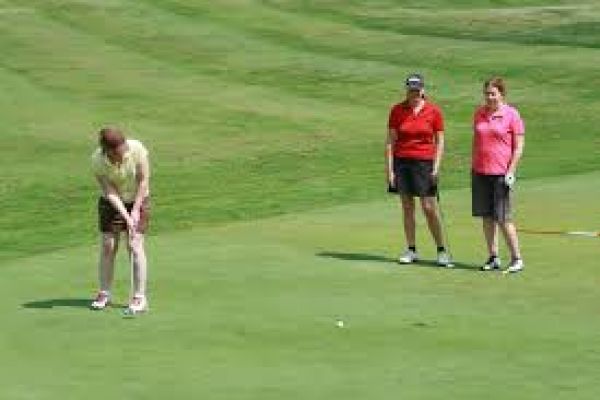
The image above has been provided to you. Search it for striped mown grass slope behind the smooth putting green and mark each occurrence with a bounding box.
[0,0,600,260]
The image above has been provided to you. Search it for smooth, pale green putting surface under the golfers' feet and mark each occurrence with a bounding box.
[0,173,600,400]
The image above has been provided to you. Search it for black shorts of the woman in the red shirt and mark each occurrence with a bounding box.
[394,158,437,197]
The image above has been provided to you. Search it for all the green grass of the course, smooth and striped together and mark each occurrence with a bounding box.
[0,0,600,400]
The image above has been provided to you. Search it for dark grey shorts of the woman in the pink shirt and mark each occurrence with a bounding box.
[471,172,512,222]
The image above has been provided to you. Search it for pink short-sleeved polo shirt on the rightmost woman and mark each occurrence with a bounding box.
[473,104,525,175]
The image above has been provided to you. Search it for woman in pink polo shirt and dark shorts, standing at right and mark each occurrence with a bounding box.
[471,77,525,272]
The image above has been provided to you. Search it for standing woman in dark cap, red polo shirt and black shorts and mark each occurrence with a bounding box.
[386,74,452,266]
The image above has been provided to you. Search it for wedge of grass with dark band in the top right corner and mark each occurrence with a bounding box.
[269,0,600,48]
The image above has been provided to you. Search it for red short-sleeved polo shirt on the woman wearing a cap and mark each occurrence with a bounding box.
[388,101,444,160]
